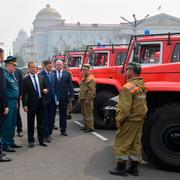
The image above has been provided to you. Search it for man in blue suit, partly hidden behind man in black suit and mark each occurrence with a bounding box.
[39,60,55,143]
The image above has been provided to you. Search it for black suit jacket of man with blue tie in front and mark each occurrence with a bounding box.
[21,74,47,110]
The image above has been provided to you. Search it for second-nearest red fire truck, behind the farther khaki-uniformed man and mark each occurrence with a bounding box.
[71,44,127,112]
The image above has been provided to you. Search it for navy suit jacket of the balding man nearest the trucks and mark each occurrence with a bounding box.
[51,70,74,101]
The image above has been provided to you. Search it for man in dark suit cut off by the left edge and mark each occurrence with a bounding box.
[0,48,11,162]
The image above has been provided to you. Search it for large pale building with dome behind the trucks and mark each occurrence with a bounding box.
[13,5,180,64]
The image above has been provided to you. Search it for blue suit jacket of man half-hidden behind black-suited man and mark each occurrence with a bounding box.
[39,70,53,104]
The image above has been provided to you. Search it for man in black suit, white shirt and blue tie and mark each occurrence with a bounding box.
[21,61,48,147]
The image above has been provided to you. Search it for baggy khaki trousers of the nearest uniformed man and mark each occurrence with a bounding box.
[114,121,144,161]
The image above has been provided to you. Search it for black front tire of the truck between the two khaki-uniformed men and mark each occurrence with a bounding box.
[94,91,115,129]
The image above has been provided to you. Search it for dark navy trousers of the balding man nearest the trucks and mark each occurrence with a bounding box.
[58,100,68,133]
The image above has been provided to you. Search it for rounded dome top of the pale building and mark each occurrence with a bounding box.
[36,4,61,18]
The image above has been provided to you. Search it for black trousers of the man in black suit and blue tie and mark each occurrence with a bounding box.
[27,100,43,143]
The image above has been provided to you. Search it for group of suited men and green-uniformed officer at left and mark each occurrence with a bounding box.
[0,49,74,162]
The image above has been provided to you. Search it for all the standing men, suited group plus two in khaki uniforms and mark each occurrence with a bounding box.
[0,49,147,176]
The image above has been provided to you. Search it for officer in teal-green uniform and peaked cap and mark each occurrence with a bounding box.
[2,56,21,152]
